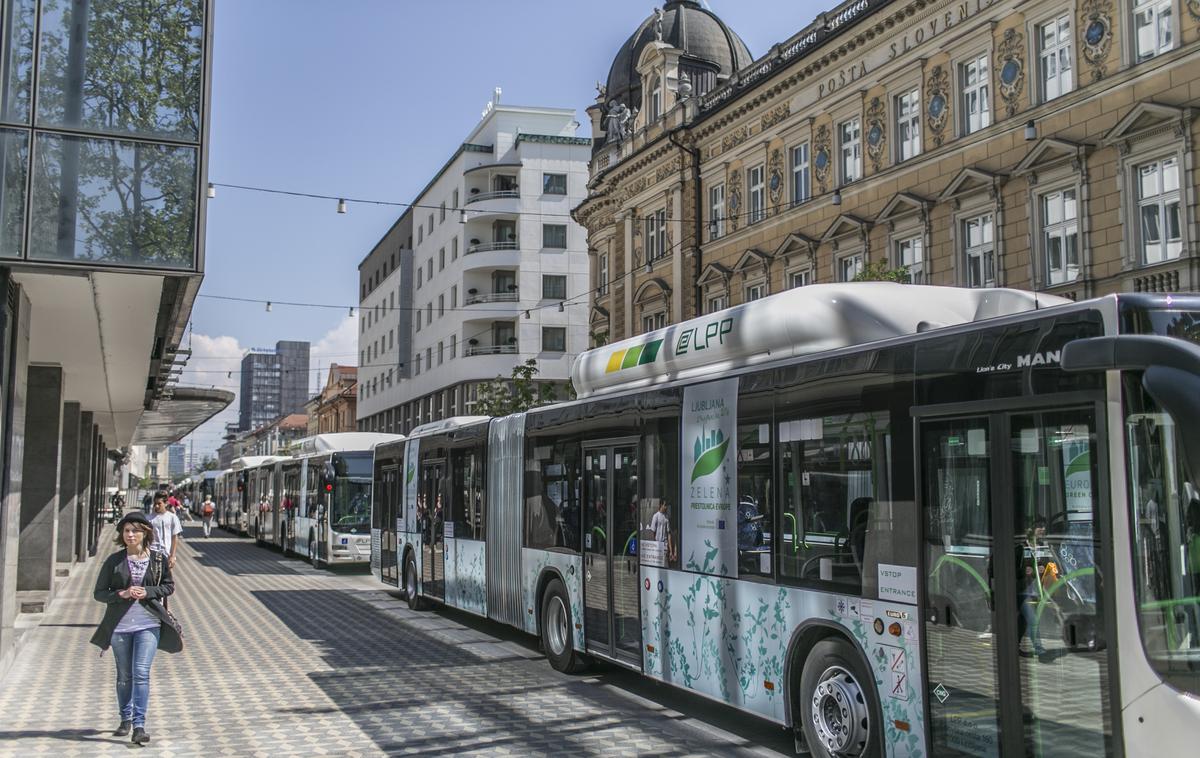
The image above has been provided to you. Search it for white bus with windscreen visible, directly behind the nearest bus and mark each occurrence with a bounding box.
[246,432,402,566]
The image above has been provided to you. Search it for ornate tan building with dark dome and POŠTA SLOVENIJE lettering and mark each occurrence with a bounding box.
[576,0,1200,342]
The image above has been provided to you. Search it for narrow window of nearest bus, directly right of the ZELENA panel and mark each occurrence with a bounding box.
[737,397,774,578]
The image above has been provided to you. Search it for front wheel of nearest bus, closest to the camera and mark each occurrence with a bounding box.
[797,637,883,758]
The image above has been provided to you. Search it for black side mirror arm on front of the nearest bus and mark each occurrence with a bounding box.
[1062,335,1200,479]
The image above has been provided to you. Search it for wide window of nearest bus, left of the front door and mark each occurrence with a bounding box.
[778,411,892,594]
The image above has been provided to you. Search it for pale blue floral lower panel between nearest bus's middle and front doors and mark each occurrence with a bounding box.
[641,566,925,758]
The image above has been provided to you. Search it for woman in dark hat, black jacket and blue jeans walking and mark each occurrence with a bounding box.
[91,511,184,745]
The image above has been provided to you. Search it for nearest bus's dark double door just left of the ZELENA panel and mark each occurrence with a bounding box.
[583,441,642,666]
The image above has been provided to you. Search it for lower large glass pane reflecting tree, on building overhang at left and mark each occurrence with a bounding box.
[29,134,197,269]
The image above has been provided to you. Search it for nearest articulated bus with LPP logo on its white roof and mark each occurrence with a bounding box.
[372,283,1200,758]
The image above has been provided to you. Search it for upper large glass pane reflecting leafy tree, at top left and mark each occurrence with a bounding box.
[37,0,204,142]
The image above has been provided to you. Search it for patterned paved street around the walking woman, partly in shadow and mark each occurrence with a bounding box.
[0,528,791,756]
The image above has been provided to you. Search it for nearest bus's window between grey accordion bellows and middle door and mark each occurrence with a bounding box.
[524,437,580,552]
